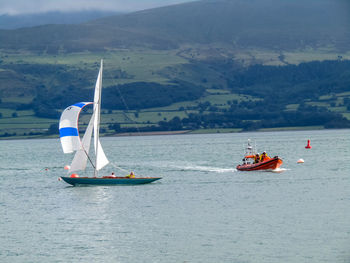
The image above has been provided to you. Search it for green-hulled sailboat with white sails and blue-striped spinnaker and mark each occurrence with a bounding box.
[59,60,161,186]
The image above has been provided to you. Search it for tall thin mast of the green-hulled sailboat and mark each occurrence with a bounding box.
[94,59,103,177]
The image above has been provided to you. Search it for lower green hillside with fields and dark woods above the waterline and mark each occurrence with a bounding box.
[0,54,350,138]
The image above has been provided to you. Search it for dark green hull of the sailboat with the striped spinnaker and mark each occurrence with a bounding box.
[61,176,161,186]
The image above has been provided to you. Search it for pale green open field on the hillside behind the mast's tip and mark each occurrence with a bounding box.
[0,50,188,86]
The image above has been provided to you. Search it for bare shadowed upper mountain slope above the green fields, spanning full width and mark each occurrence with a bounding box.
[0,0,350,53]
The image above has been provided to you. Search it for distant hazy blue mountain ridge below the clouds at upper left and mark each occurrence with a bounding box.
[0,11,121,29]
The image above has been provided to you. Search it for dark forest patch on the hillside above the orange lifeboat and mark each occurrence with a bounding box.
[223,60,350,104]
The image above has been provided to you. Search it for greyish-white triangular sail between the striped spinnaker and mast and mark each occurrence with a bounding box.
[68,113,94,173]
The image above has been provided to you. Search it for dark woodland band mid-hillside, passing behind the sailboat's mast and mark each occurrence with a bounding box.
[26,81,205,118]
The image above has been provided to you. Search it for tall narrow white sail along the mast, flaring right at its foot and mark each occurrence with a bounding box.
[93,60,109,171]
